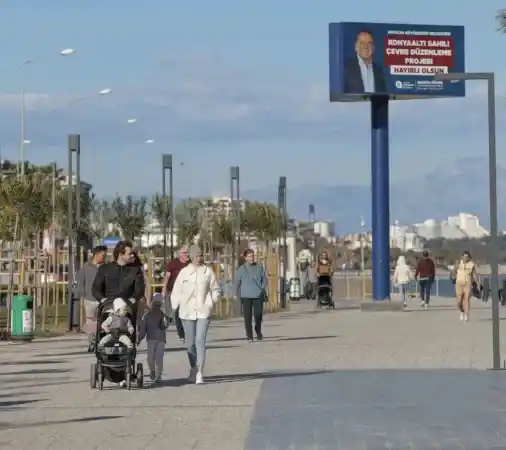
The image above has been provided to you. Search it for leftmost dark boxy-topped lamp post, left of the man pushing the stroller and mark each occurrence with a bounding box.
[67,134,81,331]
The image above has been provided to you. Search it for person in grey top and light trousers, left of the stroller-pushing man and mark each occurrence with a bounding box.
[76,245,107,352]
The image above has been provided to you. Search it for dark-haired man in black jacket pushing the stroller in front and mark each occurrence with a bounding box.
[91,241,146,317]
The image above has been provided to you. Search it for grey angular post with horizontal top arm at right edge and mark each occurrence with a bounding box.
[434,72,501,369]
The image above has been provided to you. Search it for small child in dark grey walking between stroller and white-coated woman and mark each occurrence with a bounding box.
[137,294,170,382]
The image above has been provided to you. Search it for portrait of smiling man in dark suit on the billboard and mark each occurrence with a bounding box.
[344,30,387,94]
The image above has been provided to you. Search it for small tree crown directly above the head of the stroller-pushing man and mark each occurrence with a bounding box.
[111,195,148,241]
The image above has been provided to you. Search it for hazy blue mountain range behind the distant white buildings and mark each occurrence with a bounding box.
[244,157,506,234]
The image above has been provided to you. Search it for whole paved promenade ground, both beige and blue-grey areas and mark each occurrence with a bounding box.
[0,298,506,450]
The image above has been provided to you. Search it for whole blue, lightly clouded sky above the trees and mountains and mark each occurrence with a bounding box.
[0,0,506,197]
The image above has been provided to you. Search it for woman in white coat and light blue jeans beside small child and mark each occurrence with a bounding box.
[170,245,220,384]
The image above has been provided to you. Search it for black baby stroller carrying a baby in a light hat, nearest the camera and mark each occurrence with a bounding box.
[90,301,144,390]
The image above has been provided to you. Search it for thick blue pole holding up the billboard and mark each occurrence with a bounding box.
[371,95,390,301]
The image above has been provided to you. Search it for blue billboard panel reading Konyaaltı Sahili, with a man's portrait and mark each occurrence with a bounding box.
[329,22,466,102]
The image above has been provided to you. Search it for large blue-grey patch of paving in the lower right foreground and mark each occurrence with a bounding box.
[244,369,506,450]
